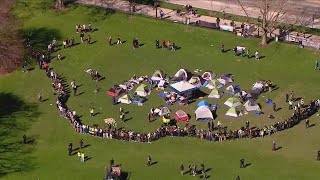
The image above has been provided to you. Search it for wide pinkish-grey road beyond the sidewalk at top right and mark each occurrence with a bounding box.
[167,0,320,29]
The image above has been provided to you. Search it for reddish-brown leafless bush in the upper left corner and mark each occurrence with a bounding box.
[0,0,24,75]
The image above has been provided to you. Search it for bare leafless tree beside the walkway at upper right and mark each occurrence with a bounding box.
[238,0,289,45]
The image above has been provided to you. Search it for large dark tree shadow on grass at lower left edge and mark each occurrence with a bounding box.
[0,93,40,178]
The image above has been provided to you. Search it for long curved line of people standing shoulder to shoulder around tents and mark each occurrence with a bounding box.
[42,63,320,143]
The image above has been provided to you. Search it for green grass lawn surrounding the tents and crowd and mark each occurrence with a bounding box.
[0,1,320,180]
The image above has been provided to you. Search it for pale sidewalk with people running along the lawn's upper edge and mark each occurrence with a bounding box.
[76,0,320,48]
